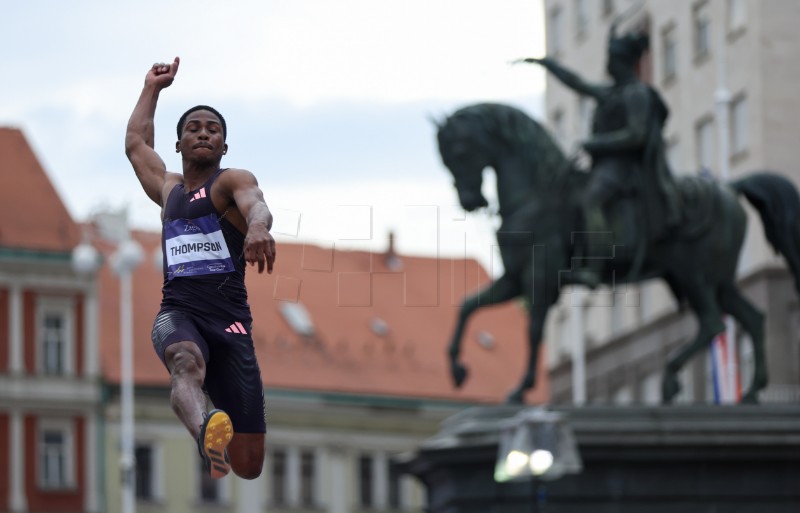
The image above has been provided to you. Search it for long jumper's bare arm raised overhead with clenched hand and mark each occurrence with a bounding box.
[125,57,180,206]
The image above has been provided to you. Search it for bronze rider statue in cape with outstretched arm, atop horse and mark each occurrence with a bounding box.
[521,25,679,287]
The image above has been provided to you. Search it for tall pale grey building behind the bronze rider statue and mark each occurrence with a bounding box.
[544,0,800,403]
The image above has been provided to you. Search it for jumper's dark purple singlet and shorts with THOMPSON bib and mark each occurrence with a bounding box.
[152,169,266,433]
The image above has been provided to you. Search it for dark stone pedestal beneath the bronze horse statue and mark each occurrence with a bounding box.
[399,405,800,513]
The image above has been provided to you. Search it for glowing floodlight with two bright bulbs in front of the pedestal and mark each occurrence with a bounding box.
[494,407,583,505]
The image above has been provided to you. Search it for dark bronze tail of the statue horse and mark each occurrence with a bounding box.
[730,172,800,294]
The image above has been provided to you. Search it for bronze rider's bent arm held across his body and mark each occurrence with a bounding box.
[583,84,653,154]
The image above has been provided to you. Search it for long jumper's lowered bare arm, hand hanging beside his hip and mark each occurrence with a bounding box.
[217,169,276,274]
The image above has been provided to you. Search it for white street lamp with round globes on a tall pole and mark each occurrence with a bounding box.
[72,217,143,513]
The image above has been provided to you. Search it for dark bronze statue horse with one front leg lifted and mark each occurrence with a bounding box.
[437,103,800,403]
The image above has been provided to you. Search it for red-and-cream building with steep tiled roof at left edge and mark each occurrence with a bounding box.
[0,128,103,513]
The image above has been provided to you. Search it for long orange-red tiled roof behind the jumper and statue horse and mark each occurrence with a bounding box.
[100,232,549,403]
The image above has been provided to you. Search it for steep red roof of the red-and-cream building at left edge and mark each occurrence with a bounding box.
[0,127,80,251]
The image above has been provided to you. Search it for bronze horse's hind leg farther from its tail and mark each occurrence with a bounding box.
[661,280,725,404]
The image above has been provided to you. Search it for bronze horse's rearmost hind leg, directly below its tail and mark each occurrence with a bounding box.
[720,283,767,404]
